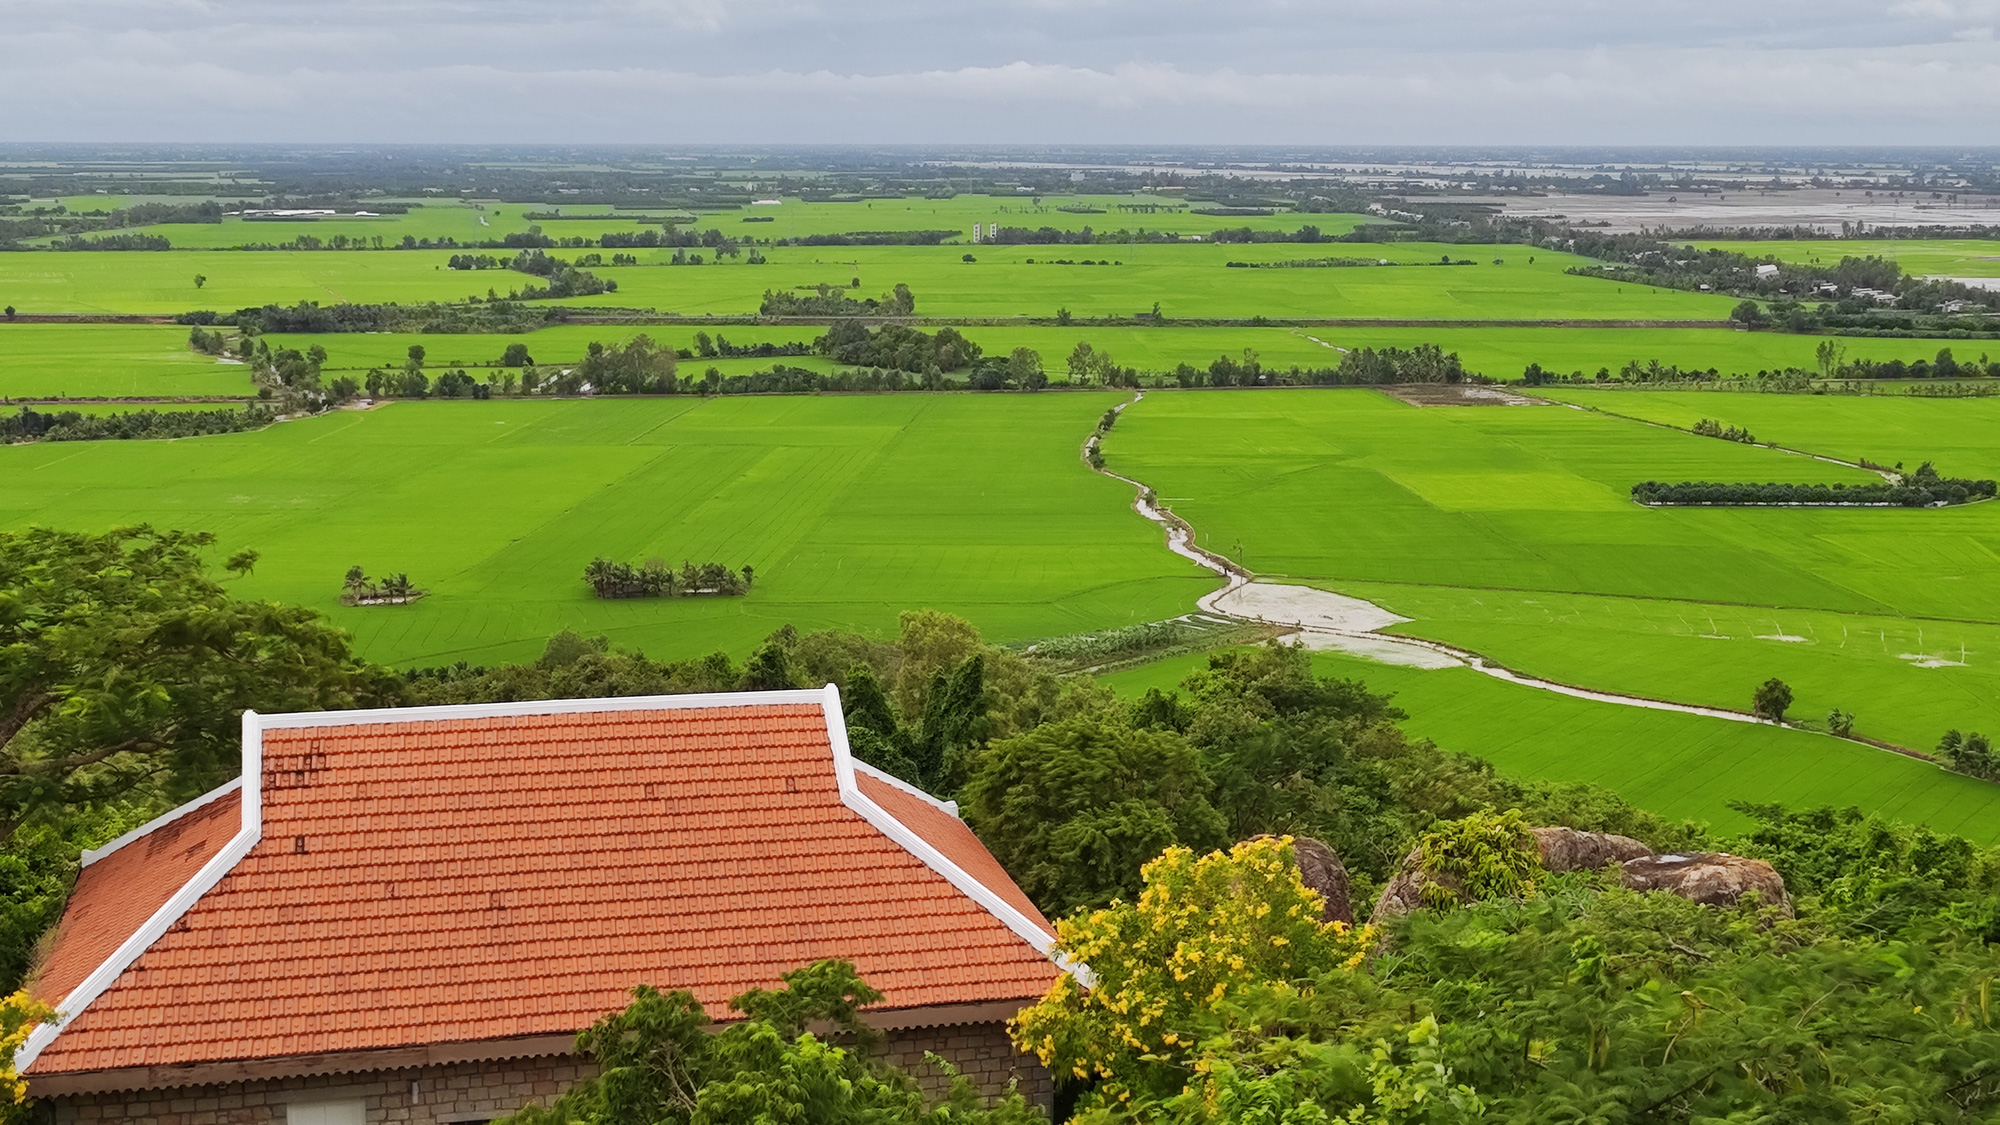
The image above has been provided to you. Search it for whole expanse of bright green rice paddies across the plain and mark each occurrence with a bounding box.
[11,196,2000,841]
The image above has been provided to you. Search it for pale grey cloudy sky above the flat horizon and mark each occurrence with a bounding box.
[11,0,2000,146]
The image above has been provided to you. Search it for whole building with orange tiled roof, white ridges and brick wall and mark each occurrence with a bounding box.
[18,687,1060,1125]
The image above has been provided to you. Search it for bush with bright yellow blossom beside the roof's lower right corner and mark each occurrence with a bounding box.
[1012,837,1372,1101]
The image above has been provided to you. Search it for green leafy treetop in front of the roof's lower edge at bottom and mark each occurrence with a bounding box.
[506,961,1040,1125]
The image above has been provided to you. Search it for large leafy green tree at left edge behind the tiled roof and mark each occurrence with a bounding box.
[0,524,400,837]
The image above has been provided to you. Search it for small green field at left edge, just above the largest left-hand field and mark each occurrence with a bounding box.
[0,322,254,398]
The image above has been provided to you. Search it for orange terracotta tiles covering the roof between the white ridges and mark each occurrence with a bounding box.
[28,705,1058,1075]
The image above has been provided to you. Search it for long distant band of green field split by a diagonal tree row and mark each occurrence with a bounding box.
[0,242,1732,320]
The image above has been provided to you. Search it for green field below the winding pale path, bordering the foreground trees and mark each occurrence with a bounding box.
[1104,653,2000,845]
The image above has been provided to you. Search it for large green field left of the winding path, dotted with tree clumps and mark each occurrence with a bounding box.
[0,394,1212,665]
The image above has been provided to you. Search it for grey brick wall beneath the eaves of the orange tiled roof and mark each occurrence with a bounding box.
[50,1023,1054,1125]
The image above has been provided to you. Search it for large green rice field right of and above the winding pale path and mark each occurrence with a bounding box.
[1106,380,2000,749]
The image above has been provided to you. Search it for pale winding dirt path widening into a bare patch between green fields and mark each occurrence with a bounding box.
[1082,390,1928,740]
